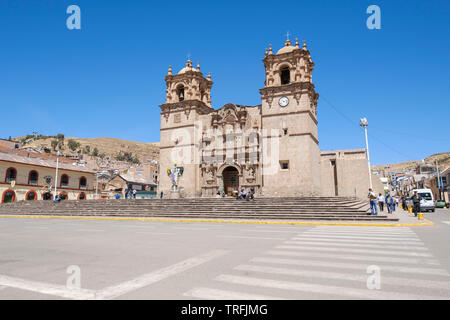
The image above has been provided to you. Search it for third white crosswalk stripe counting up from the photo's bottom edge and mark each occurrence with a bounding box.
[234,265,450,290]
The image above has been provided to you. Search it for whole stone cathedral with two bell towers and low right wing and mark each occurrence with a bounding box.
[159,39,378,198]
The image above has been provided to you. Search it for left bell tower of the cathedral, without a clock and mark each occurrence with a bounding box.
[159,59,214,197]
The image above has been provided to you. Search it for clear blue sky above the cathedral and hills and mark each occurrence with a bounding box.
[0,0,450,164]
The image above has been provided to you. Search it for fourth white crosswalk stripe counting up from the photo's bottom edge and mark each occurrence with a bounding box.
[250,257,450,277]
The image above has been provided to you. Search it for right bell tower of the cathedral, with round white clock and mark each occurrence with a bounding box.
[260,39,320,196]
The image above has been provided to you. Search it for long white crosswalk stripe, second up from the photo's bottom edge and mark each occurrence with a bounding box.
[215,274,446,300]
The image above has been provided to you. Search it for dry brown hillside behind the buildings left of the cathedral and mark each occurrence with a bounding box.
[17,137,159,162]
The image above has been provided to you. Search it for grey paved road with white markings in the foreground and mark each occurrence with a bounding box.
[0,210,450,299]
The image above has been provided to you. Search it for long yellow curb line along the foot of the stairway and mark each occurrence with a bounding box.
[0,215,434,227]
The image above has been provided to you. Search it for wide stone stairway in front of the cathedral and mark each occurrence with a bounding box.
[0,197,398,222]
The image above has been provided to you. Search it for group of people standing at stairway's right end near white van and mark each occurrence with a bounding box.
[367,189,422,217]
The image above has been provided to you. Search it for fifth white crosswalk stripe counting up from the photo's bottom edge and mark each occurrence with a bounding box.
[266,251,440,265]
